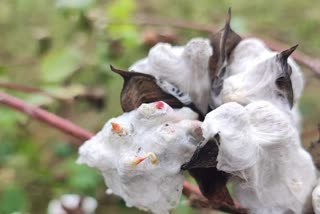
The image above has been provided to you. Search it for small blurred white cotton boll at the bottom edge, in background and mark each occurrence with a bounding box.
[48,194,97,214]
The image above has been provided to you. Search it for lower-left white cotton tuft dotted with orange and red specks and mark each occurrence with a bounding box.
[78,101,202,214]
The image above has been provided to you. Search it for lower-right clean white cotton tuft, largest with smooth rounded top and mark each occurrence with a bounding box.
[201,101,316,214]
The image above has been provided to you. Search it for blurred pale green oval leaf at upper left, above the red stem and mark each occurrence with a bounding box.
[40,48,82,83]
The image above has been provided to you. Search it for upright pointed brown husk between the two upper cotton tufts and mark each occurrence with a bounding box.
[209,8,242,81]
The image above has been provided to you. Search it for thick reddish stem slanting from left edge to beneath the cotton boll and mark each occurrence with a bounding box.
[0,92,243,213]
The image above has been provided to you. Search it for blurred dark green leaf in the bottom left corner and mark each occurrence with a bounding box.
[0,185,27,213]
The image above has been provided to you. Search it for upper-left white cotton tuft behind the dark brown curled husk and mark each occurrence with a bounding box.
[129,38,212,113]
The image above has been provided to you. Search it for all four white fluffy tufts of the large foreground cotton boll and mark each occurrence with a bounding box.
[78,10,320,214]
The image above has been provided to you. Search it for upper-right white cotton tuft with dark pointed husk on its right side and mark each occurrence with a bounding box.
[212,38,303,127]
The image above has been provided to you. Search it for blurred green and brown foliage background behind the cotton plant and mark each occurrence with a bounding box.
[0,0,320,214]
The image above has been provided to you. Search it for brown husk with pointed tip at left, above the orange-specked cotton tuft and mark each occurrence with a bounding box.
[110,65,203,118]
